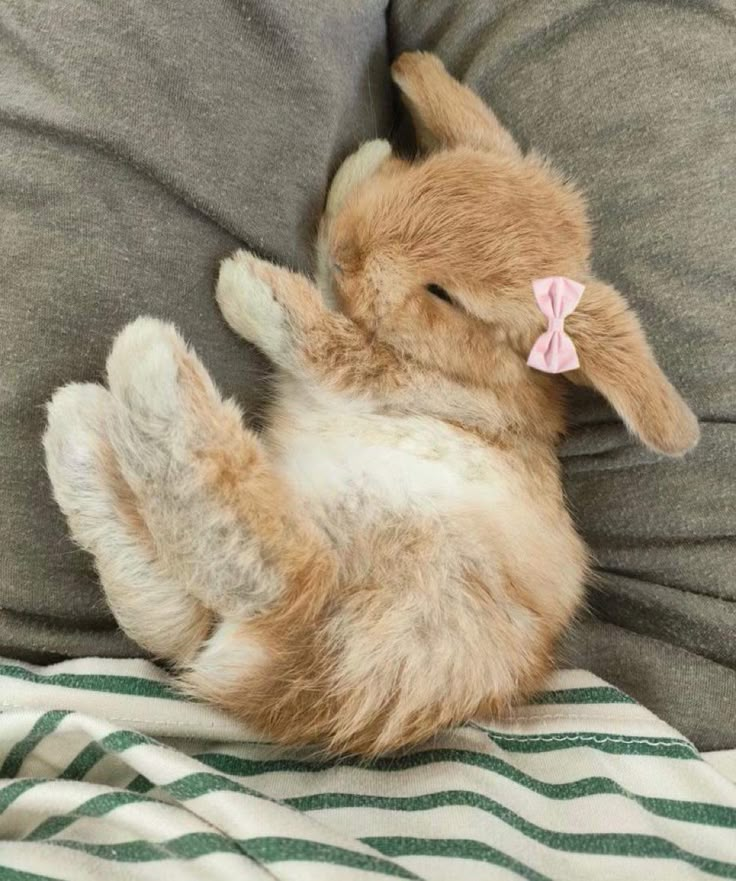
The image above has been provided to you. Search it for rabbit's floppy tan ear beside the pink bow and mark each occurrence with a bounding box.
[566,280,699,456]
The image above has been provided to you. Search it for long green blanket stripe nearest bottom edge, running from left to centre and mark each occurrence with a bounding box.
[40,832,417,879]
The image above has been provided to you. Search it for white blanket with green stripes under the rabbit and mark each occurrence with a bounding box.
[0,658,736,881]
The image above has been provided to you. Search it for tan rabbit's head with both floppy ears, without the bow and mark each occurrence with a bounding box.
[321,53,698,455]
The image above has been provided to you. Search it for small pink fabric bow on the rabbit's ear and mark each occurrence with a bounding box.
[526,275,585,373]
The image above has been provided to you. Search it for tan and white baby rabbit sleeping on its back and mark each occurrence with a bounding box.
[44,53,698,756]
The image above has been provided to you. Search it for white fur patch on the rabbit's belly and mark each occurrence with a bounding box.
[271,388,515,521]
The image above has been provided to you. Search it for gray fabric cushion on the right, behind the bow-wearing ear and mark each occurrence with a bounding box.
[390,0,736,749]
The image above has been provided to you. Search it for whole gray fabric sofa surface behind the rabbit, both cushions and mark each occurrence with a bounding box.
[0,0,736,749]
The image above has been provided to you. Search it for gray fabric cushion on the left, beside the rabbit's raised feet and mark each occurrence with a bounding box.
[0,0,391,659]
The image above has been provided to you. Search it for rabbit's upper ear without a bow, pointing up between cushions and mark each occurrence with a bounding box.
[391,52,521,158]
